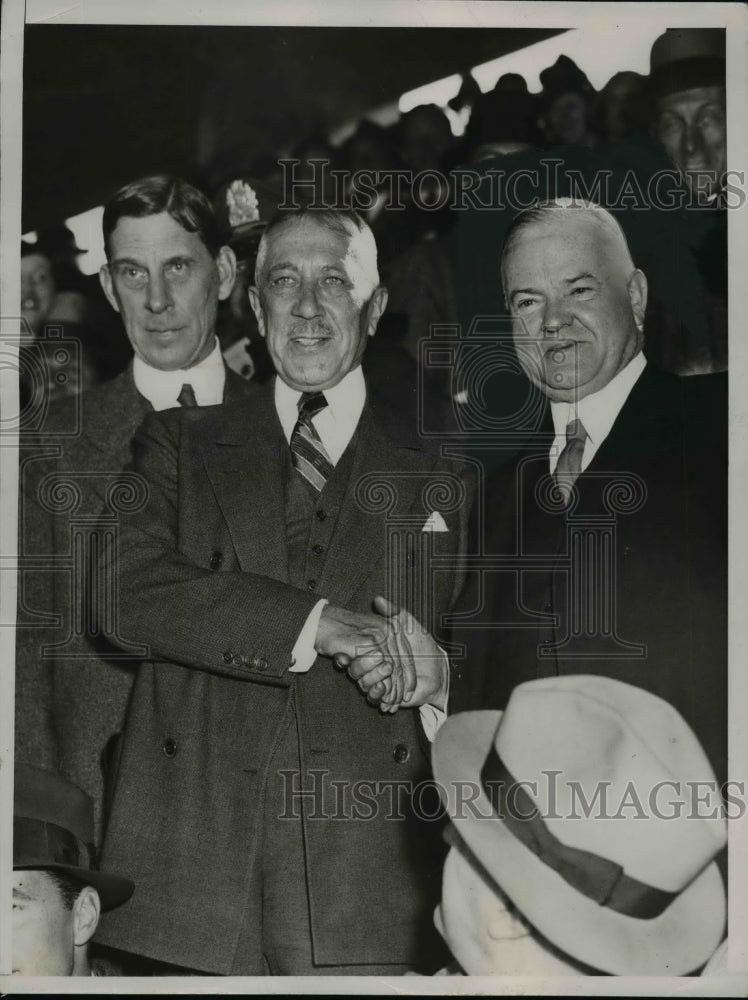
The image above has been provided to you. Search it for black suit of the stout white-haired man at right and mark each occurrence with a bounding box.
[450,367,727,780]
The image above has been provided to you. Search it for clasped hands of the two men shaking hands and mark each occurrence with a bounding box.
[314,597,448,713]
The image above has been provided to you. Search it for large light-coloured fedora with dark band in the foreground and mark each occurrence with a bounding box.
[433,675,726,975]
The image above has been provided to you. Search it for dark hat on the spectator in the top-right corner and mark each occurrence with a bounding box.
[649,28,725,97]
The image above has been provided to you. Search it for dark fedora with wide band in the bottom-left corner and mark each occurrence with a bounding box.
[13,764,134,910]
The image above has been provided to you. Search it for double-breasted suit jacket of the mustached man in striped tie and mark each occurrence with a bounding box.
[96,384,470,974]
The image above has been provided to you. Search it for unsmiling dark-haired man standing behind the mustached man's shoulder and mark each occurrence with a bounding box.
[16,176,249,839]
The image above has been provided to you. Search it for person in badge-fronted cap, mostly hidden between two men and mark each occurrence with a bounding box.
[213,176,283,382]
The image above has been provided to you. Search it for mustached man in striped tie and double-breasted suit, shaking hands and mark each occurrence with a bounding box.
[96,211,470,975]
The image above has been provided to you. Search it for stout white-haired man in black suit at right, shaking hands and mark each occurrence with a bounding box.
[450,199,727,781]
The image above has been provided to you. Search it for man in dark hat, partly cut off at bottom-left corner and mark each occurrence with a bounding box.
[11,764,133,976]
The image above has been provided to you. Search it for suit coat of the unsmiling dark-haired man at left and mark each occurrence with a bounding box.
[16,366,249,830]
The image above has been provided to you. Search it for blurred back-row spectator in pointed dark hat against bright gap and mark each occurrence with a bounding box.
[540,56,597,146]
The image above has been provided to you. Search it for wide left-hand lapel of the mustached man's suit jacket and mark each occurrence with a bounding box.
[201,382,288,581]
